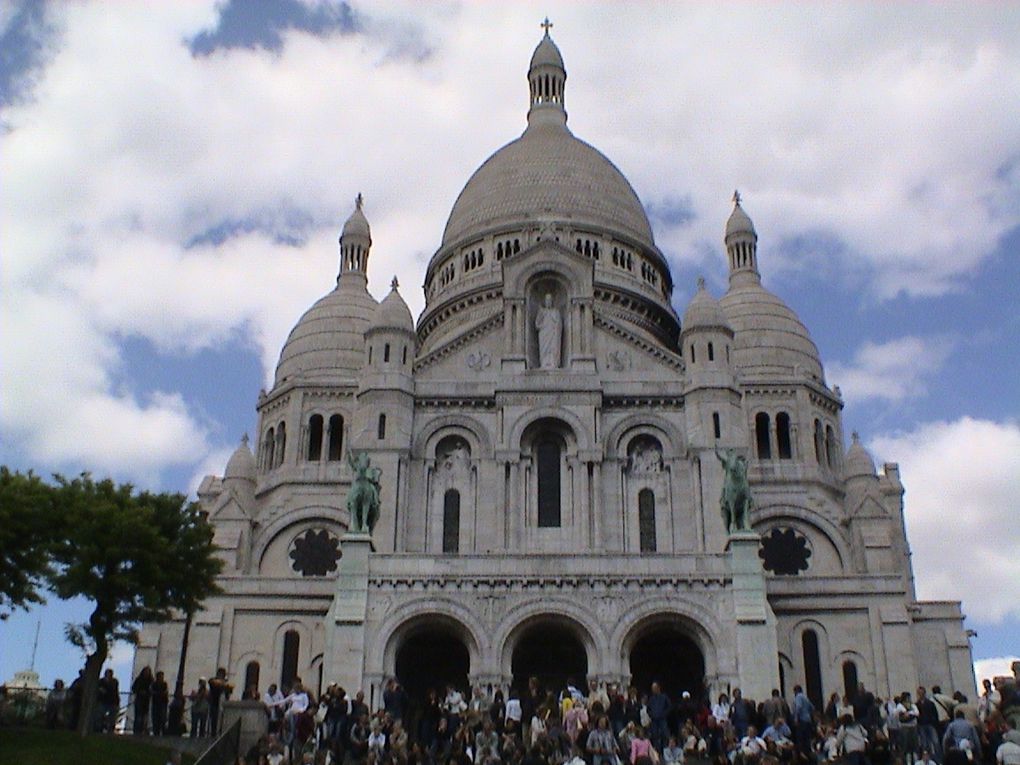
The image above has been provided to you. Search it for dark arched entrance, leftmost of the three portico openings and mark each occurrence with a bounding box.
[394,622,471,708]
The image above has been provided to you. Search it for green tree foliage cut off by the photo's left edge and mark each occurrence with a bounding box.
[0,467,54,619]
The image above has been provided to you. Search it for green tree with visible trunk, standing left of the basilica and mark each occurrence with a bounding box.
[50,474,222,734]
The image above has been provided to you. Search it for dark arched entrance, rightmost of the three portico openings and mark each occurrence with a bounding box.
[630,623,705,699]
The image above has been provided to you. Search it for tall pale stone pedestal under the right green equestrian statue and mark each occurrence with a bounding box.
[726,531,779,699]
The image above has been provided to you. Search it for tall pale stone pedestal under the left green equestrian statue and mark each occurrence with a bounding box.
[322,531,375,698]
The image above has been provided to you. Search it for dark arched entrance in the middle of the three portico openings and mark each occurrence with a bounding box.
[510,619,588,692]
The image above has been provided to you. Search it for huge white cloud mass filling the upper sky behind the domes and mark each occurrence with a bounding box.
[0,1,1020,491]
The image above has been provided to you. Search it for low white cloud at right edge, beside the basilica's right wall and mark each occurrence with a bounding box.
[869,417,1020,622]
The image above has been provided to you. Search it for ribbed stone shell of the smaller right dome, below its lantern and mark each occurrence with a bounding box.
[719,281,822,381]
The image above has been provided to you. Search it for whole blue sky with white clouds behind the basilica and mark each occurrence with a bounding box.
[0,0,1020,693]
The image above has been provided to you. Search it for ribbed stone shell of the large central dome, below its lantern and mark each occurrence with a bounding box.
[443,119,654,246]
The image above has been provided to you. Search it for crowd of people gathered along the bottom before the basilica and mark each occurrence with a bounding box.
[27,667,1020,765]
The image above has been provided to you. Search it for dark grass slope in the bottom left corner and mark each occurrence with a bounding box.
[0,728,192,765]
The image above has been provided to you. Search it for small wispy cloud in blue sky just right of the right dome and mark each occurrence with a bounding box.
[826,336,954,403]
